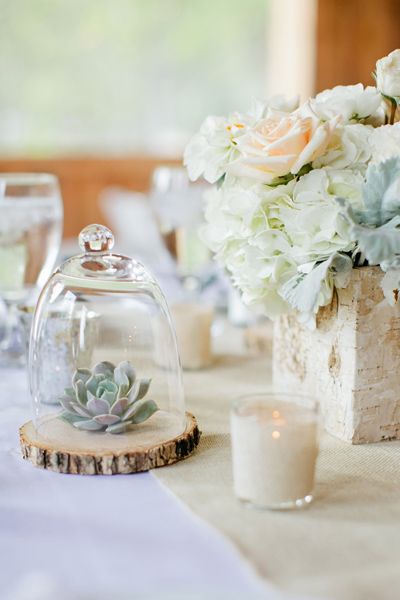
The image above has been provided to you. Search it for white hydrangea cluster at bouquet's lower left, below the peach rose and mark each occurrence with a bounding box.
[202,180,296,316]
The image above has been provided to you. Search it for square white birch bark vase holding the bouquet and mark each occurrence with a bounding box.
[273,267,400,444]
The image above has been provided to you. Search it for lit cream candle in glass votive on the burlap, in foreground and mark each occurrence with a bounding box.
[231,392,319,510]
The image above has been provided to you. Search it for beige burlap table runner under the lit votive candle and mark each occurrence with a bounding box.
[153,342,400,600]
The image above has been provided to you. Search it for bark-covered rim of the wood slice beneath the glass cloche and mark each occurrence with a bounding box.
[19,413,201,475]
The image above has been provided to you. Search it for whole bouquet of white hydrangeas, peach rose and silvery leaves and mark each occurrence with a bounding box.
[184,50,400,327]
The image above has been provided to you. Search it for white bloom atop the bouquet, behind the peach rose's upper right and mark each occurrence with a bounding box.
[310,83,382,123]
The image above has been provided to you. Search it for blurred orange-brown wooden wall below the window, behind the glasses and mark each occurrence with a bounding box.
[0,157,178,238]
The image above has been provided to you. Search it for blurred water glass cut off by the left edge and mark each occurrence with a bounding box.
[0,173,63,367]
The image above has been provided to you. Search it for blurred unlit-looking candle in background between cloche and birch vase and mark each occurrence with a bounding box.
[171,303,214,369]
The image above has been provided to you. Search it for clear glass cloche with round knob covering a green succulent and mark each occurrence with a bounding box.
[29,225,195,472]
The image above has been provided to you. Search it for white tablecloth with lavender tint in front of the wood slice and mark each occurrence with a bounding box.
[0,371,296,600]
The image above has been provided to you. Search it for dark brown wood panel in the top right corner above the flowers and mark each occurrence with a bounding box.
[316,0,400,91]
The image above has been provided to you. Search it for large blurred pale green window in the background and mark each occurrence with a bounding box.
[0,0,268,156]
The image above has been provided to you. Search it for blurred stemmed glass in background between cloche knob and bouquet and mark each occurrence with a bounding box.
[150,166,215,294]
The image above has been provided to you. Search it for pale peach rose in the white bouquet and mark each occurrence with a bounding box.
[228,112,338,183]
